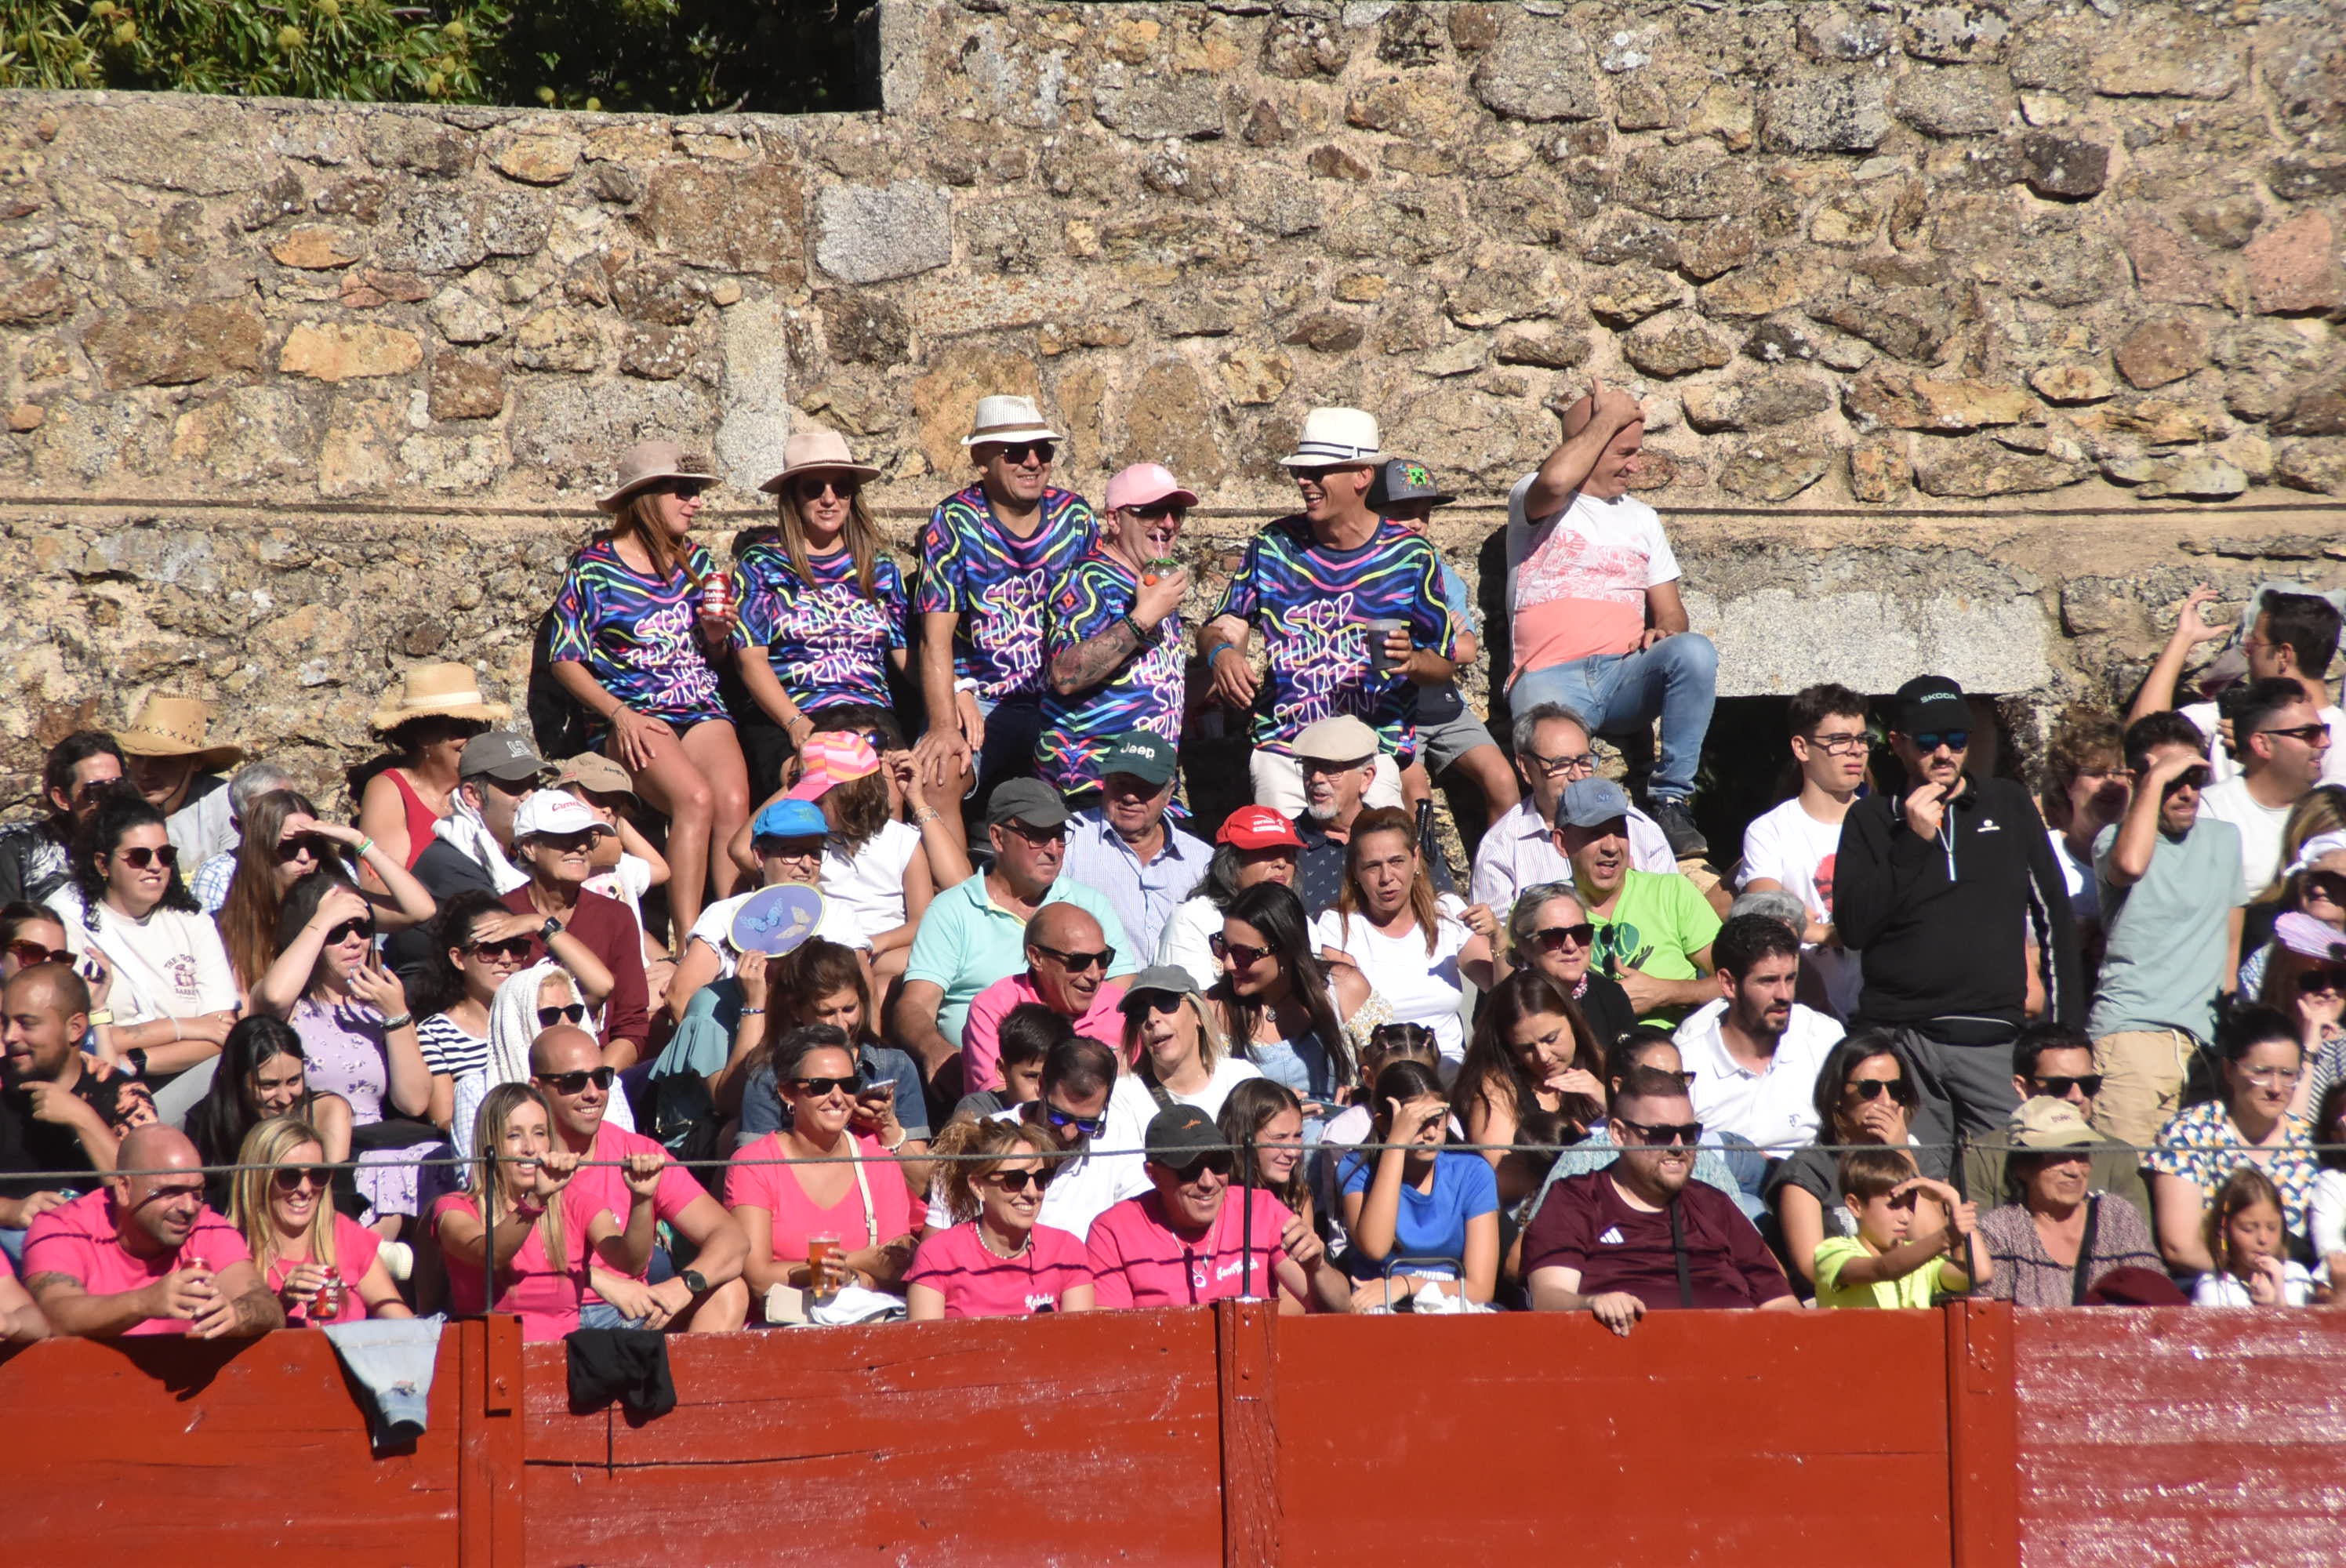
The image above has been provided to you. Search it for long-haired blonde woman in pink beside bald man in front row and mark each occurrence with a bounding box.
[227,1115,416,1329]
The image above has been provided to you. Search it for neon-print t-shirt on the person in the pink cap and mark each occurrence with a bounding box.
[1034,550,1182,793]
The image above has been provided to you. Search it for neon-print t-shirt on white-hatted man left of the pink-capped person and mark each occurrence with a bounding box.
[913,486,1100,702]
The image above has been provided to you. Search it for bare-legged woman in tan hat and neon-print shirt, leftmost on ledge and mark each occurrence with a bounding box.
[547,441,748,935]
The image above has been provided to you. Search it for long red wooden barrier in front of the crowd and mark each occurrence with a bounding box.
[0,1305,2346,1568]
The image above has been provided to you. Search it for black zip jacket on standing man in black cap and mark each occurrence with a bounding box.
[1832,775,2086,1037]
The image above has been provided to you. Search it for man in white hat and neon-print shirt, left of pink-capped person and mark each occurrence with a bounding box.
[913,397,1100,844]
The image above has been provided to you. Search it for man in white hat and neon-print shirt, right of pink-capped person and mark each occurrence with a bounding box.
[1199,408,1457,817]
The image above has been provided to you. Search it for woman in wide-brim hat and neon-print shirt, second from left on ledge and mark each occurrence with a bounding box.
[734,430,908,800]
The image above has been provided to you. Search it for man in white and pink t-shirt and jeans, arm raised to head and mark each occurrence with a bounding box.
[1506,380,1720,857]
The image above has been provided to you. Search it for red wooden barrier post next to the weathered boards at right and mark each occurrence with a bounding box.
[1945,1301,2020,1568]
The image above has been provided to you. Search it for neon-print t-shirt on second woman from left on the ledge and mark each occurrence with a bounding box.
[734,533,906,713]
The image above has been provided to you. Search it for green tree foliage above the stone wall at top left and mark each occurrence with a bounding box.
[0,0,866,113]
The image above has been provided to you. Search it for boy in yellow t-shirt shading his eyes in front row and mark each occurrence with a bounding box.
[1816,1148,1994,1308]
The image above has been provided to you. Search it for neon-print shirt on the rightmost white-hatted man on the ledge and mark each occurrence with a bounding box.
[1215,517,1457,765]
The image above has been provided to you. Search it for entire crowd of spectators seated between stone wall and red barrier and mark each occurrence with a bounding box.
[0,385,2346,1341]
